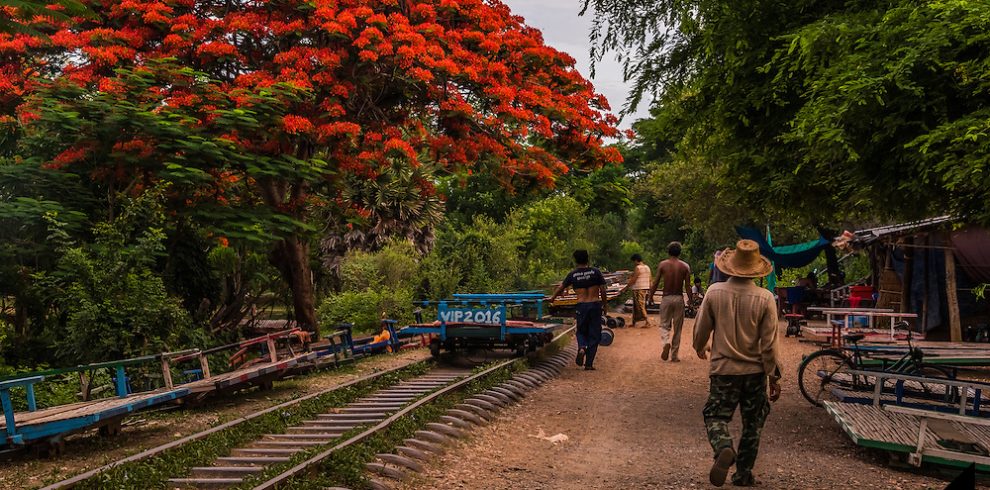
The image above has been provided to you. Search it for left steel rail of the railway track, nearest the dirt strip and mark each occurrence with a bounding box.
[41,359,429,490]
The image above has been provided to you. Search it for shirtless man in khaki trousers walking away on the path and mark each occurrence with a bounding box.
[648,242,691,362]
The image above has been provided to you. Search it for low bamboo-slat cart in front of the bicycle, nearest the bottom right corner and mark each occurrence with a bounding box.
[824,370,990,472]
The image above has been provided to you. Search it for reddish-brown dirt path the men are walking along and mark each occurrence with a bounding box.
[408,319,946,490]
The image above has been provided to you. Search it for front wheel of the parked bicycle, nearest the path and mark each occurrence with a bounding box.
[798,349,861,407]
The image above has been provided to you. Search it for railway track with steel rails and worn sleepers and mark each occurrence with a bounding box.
[43,329,571,490]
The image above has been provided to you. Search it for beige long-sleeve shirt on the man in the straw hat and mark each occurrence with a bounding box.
[694,277,781,378]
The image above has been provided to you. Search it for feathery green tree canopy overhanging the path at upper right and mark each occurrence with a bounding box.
[584,0,990,225]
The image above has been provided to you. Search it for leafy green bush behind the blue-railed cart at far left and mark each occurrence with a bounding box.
[38,192,202,364]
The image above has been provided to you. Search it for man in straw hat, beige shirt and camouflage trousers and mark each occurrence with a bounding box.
[694,240,780,486]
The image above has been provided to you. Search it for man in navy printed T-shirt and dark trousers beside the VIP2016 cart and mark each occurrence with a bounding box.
[548,250,608,371]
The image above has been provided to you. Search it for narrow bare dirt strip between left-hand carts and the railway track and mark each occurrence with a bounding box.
[0,349,430,489]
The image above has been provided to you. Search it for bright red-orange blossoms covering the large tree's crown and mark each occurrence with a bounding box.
[0,0,621,203]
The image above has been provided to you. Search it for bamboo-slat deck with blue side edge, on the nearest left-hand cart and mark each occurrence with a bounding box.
[0,388,190,447]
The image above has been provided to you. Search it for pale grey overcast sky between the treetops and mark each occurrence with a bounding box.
[502,0,649,129]
